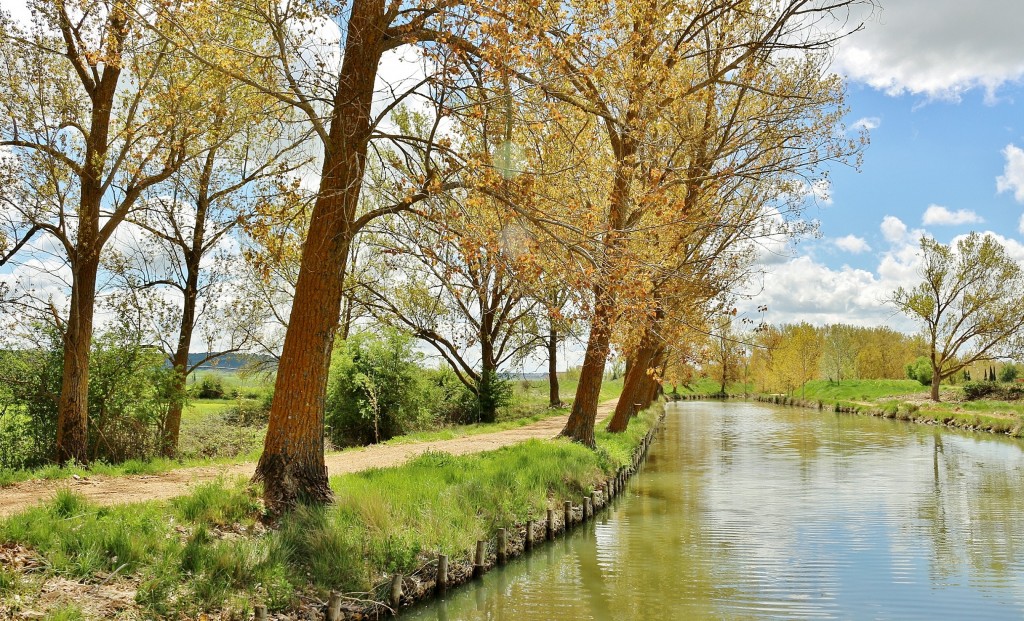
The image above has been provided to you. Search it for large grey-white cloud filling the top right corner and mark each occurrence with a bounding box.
[837,0,1024,99]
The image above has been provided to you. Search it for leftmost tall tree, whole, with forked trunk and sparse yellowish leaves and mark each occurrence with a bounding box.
[0,0,191,464]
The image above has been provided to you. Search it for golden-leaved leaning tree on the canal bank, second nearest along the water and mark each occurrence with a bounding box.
[499,0,868,446]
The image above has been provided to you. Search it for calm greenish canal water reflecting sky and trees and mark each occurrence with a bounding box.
[403,402,1024,621]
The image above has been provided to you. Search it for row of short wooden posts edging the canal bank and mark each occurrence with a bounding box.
[248,414,664,621]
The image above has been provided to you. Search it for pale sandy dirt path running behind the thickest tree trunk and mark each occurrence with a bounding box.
[0,400,615,518]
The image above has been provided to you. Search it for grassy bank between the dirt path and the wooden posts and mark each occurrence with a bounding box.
[0,412,657,620]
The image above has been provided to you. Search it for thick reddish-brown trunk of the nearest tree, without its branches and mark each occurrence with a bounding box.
[253,0,384,514]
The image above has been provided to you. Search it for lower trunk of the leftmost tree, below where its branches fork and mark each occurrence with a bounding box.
[56,258,99,465]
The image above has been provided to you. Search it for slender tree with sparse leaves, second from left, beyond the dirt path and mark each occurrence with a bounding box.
[111,80,306,457]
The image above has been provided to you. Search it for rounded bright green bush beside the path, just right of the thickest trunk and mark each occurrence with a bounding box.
[326,329,430,446]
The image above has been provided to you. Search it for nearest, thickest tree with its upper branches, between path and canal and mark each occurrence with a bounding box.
[156,0,471,513]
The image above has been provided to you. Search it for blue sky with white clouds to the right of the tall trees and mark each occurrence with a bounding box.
[741,0,1024,331]
